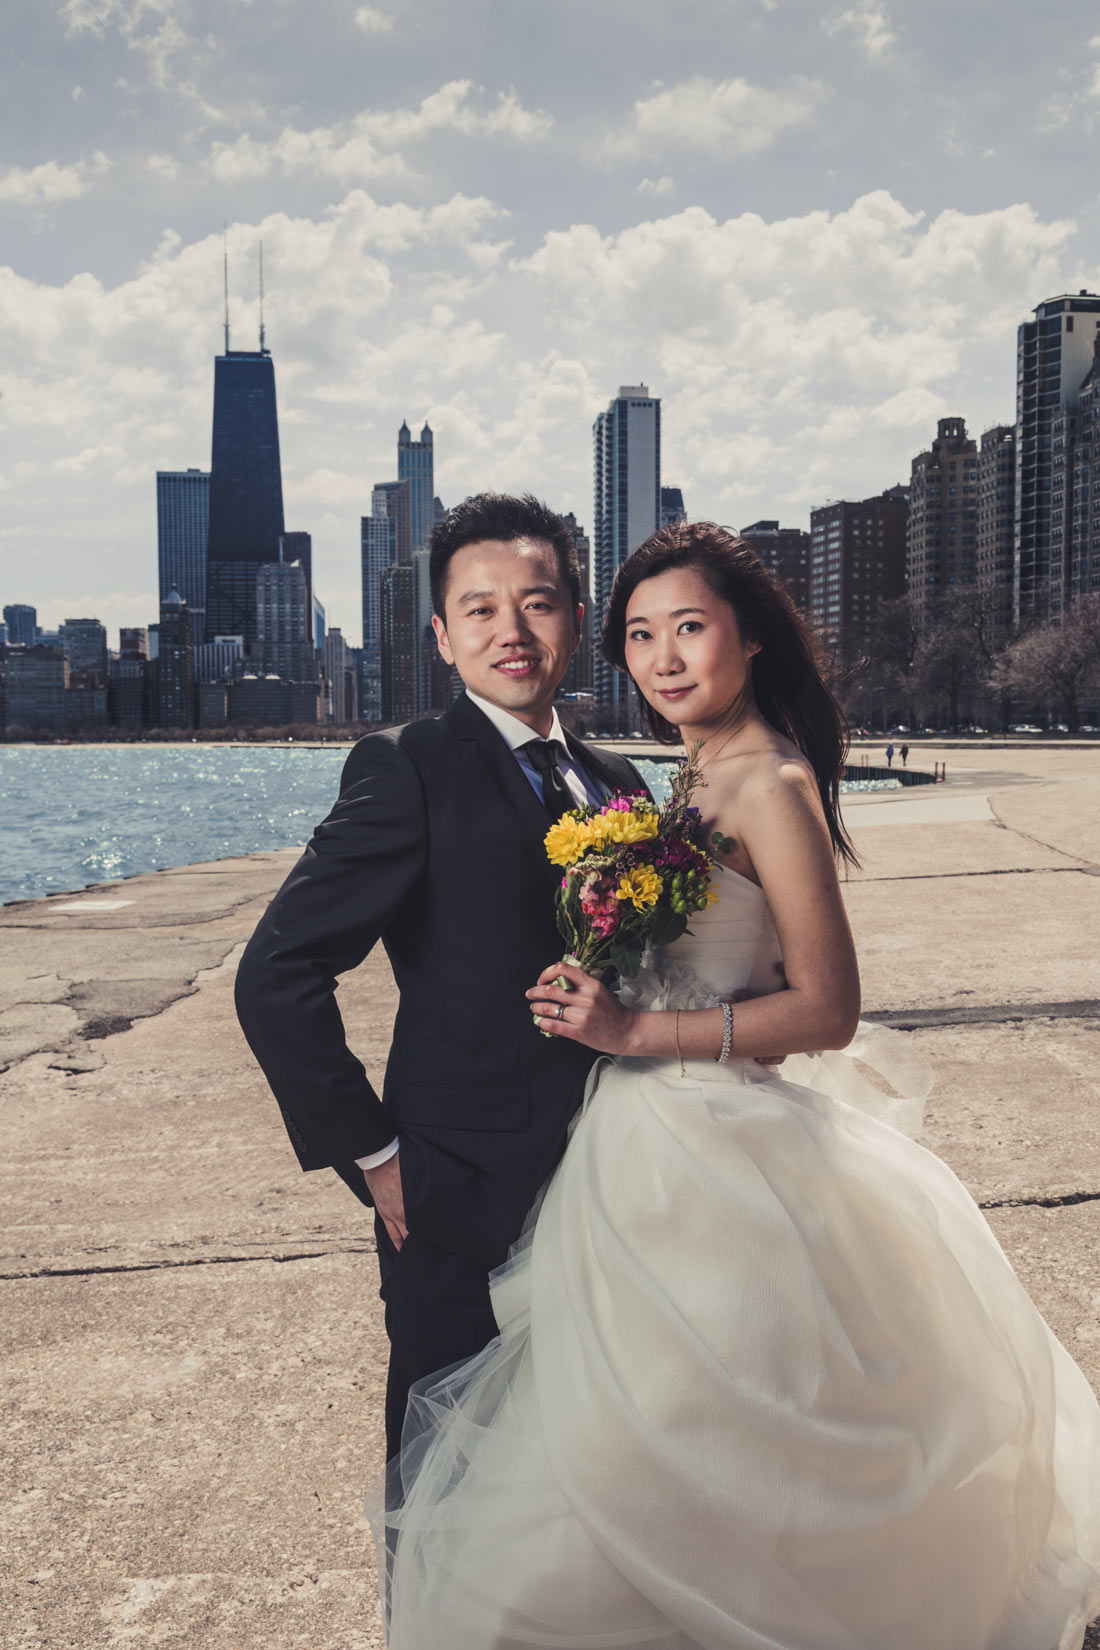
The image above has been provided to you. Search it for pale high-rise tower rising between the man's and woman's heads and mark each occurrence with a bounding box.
[592,384,661,733]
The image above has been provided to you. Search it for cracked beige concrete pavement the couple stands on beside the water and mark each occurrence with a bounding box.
[0,746,1100,1650]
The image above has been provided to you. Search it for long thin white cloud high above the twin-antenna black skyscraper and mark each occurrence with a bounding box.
[206,81,551,183]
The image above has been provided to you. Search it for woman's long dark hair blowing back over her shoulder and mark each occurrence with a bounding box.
[600,521,859,866]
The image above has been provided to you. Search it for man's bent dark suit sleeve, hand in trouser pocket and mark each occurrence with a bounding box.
[236,736,427,1168]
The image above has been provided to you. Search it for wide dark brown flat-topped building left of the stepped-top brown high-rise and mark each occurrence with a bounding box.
[808,487,909,650]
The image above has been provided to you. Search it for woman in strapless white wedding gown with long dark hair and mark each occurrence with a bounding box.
[376,525,1100,1650]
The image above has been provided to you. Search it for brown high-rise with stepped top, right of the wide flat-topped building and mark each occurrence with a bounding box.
[905,417,978,635]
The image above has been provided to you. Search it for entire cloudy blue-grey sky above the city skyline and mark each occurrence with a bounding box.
[0,0,1100,645]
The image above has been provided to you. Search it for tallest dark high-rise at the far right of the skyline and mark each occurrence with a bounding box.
[1013,290,1100,629]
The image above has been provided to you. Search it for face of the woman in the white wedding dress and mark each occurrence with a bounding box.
[625,568,760,726]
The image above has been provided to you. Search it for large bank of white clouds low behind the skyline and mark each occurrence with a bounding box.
[0,188,1095,639]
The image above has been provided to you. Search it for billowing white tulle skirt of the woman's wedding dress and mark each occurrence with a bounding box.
[368,1026,1100,1650]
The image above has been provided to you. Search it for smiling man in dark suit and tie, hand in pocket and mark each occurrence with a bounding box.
[236,493,645,1455]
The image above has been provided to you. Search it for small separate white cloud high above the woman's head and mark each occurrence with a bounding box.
[605,74,823,158]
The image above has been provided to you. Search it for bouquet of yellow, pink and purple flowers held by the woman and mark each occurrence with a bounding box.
[546,751,717,980]
